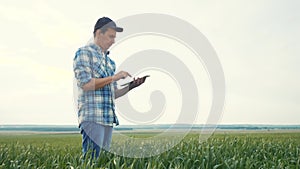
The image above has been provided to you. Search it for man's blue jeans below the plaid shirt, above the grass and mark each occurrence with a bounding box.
[80,122,113,158]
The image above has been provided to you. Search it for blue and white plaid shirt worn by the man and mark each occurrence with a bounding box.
[73,43,118,126]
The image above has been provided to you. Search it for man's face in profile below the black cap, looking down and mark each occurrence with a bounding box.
[96,28,116,51]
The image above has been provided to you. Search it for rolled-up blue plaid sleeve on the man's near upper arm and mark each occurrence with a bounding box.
[73,49,92,88]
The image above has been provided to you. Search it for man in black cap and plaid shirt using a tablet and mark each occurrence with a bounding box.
[73,17,145,158]
